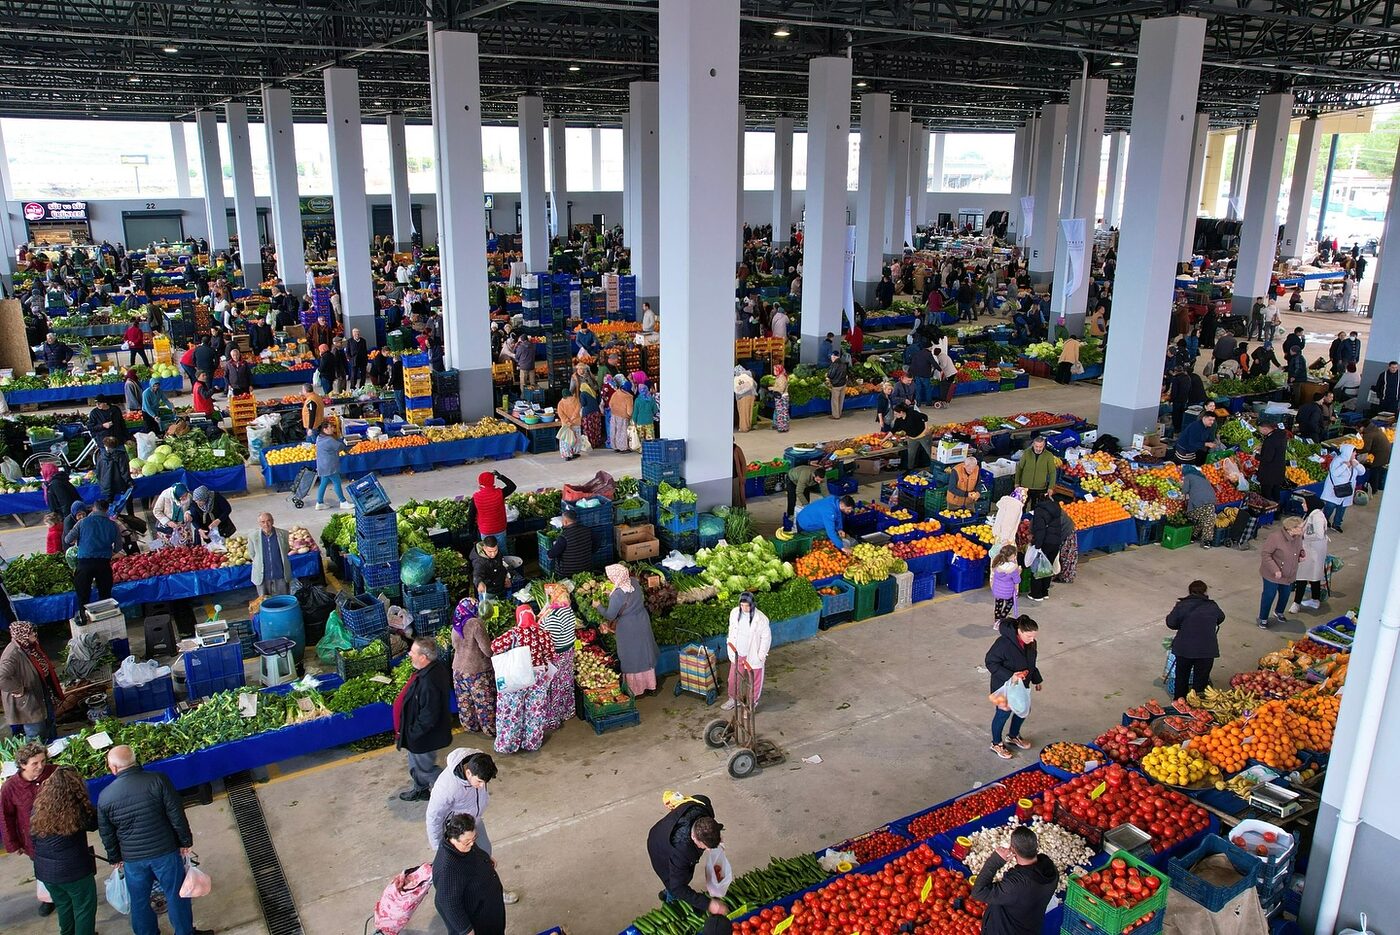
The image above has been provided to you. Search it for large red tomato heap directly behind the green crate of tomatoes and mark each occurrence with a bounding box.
[1036,763,1211,852]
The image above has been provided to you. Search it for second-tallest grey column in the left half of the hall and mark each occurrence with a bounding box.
[325,69,375,340]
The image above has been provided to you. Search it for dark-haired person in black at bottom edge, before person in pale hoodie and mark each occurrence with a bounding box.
[433,815,505,935]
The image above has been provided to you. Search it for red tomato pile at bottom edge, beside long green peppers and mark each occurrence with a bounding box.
[734,844,984,935]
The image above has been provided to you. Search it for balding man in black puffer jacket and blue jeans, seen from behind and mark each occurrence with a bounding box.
[97,745,206,935]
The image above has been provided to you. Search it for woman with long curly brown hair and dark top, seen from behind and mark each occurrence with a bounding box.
[28,767,97,935]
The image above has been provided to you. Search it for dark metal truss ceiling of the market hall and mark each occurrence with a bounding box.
[0,0,1400,130]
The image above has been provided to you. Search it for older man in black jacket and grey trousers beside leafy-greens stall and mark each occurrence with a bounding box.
[393,637,452,802]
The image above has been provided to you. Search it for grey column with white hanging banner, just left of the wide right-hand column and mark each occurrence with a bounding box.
[1050,78,1109,335]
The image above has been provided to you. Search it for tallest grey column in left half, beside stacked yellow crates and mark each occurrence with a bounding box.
[428,29,496,420]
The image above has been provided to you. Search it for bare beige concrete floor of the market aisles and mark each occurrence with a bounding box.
[0,303,1376,935]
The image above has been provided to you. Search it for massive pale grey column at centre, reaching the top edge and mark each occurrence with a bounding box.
[657,0,739,509]
